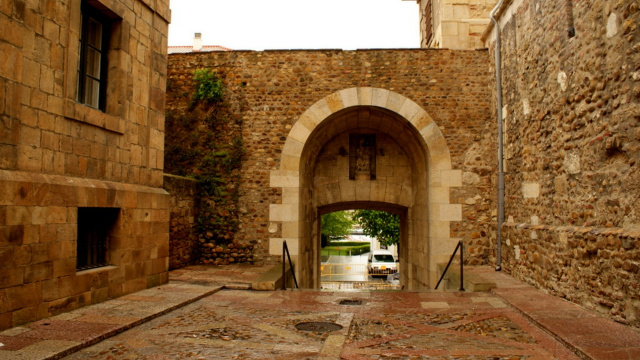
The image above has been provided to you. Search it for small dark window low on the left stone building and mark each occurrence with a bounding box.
[76,208,120,270]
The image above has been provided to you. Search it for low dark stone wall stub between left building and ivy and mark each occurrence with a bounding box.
[163,174,200,270]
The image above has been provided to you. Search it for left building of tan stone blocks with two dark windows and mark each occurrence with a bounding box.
[0,0,170,329]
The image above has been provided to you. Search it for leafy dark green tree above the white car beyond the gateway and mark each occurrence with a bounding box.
[352,210,400,246]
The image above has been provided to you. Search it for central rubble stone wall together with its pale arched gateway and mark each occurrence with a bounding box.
[167,49,495,288]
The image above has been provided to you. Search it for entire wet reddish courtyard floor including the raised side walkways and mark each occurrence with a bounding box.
[0,267,640,360]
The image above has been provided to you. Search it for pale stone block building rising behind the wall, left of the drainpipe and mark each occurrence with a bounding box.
[418,0,497,50]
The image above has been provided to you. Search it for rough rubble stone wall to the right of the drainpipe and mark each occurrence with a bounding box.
[485,0,640,327]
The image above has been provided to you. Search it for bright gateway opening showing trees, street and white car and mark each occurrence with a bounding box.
[318,203,407,290]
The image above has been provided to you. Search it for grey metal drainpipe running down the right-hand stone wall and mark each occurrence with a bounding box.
[489,0,504,271]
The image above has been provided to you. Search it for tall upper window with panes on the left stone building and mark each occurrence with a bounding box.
[77,2,111,111]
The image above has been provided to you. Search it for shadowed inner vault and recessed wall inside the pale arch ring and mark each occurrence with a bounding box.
[299,106,429,288]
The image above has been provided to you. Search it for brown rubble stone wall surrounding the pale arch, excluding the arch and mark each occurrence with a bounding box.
[167,49,495,263]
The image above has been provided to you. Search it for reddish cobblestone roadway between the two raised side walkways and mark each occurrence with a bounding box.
[65,290,578,360]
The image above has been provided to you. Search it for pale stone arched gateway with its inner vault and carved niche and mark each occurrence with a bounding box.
[269,87,462,290]
